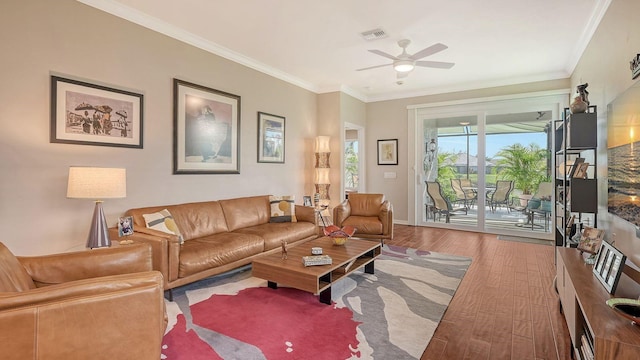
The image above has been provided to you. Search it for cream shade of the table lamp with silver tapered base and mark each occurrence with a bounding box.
[67,166,127,200]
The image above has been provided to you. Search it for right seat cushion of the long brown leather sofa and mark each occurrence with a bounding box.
[233,222,318,251]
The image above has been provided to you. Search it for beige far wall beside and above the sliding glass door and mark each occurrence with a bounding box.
[366,79,569,223]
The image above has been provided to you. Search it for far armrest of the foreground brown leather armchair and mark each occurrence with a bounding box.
[18,244,152,287]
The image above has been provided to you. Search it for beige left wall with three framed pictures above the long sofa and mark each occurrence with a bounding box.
[0,0,317,255]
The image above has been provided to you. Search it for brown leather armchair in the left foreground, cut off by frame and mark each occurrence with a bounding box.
[0,243,166,360]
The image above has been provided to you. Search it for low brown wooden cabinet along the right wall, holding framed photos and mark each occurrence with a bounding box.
[556,247,640,360]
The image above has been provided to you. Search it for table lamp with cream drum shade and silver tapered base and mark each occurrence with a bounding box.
[67,166,127,249]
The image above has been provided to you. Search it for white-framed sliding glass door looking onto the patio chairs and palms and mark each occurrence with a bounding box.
[414,96,564,239]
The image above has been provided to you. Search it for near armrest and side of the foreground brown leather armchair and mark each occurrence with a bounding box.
[0,271,166,359]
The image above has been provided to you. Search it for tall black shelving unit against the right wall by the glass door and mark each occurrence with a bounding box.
[554,106,598,246]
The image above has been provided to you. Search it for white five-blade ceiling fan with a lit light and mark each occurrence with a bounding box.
[356,39,455,78]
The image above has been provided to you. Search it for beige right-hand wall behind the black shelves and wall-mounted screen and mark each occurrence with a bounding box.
[571,0,640,266]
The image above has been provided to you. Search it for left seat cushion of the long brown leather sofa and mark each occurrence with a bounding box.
[178,233,264,278]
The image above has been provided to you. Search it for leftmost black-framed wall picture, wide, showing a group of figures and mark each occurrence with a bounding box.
[50,76,144,149]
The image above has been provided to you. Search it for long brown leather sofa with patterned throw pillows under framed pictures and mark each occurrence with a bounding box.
[116,195,318,290]
